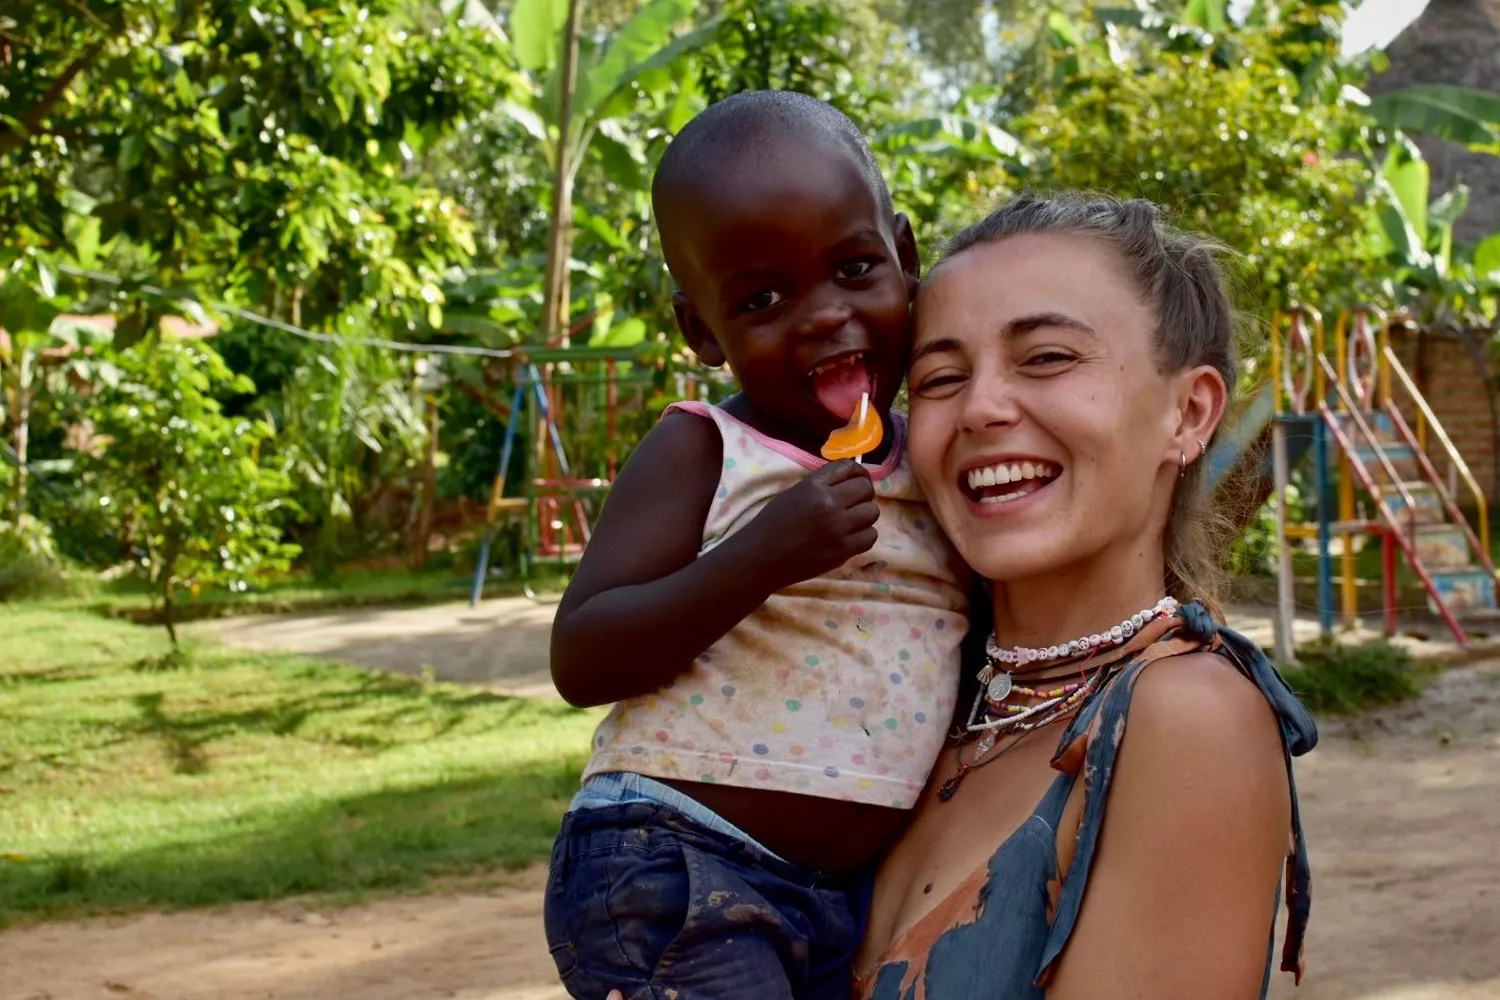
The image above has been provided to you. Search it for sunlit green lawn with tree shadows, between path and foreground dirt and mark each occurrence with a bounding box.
[0,606,597,924]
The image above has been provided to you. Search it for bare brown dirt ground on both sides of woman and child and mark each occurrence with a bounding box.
[11,661,1500,1000]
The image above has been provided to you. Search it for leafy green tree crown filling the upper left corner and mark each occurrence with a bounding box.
[0,0,498,345]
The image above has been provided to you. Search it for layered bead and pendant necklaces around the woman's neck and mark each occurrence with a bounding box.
[938,597,1179,802]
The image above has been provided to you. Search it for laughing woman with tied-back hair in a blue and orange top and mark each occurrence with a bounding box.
[857,191,1317,1000]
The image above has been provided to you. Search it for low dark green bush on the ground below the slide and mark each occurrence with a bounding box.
[1281,640,1422,715]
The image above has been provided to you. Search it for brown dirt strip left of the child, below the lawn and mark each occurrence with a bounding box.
[0,868,567,1000]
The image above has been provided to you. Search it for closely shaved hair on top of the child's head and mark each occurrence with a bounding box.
[651,90,893,267]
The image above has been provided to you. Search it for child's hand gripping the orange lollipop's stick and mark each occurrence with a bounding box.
[750,459,881,589]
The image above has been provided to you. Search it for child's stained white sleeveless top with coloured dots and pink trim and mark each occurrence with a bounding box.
[585,402,969,810]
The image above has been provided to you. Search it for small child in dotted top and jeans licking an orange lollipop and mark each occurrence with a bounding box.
[546,91,968,1000]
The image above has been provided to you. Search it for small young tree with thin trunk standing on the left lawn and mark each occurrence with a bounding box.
[87,342,296,645]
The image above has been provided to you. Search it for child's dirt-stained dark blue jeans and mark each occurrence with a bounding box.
[545,775,872,1000]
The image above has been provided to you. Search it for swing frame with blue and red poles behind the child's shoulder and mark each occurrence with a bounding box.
[470,346,726,606]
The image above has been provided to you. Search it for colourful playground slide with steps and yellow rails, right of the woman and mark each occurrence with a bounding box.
[1208,306,1496,661]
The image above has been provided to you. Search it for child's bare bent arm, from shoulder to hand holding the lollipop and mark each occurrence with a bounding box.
[552,414,878,706]
